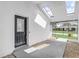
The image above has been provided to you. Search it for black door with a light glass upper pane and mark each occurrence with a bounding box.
[15,15,27,47]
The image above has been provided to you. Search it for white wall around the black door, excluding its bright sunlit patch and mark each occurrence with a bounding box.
[0,2,49,57]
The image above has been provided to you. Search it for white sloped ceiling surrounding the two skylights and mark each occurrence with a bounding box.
[33,1,79,21]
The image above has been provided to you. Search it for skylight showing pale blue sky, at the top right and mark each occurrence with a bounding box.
[66,1,75,14]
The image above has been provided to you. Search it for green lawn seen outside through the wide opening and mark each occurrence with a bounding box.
[53,31,77,40]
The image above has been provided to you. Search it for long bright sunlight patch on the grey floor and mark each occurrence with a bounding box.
[24,44,50,53]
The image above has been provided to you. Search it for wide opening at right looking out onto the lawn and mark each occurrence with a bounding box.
[52,20,78,41]
